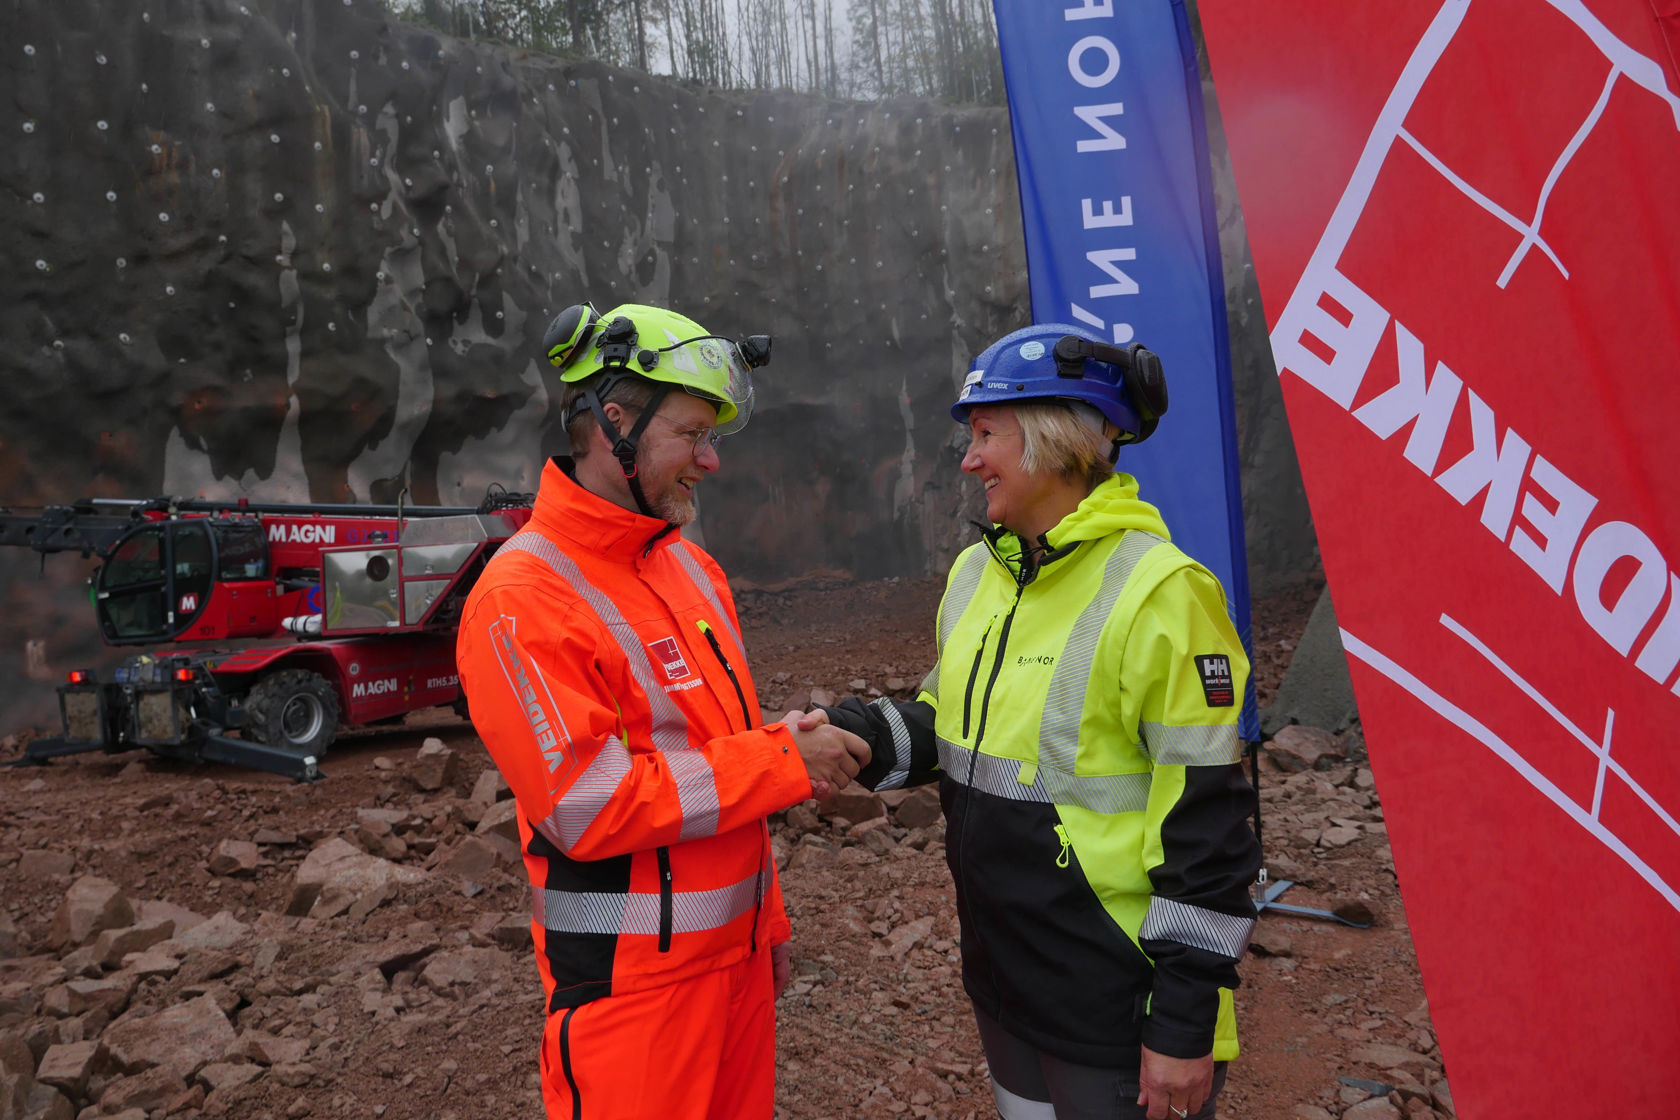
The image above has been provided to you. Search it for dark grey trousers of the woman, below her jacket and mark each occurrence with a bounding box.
[974,1007,1228,1120]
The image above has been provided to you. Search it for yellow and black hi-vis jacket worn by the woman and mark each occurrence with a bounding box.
[830,475,1260,1068]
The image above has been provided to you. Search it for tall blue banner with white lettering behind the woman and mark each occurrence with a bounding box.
[993,0,1260,741]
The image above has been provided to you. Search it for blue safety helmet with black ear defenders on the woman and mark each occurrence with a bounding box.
[951,322,1166,443]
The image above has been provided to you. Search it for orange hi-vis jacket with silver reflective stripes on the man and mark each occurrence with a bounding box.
[457,460,811,1014]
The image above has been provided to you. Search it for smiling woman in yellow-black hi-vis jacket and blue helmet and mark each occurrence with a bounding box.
[806,324,1260,1120]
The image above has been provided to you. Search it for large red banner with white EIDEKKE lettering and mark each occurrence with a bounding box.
[1200,0,1680,1120]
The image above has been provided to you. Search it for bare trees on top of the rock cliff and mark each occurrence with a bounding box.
[383,0,1003,104]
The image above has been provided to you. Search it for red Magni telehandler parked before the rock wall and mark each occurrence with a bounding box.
[0,490,531,781]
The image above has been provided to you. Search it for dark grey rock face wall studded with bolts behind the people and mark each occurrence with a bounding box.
[0,0,1312,728]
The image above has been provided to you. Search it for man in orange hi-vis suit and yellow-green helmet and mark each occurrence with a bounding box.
[457,304,869,1120]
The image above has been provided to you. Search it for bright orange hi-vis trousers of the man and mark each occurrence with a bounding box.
[543,945,776,1120]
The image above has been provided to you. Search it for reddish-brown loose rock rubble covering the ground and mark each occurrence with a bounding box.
[0,581,1453,1120]
